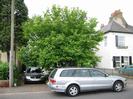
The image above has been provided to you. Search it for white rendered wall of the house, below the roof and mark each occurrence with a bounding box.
[97,32,133,69]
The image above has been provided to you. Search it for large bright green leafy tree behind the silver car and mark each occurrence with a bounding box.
[19,5,103,68]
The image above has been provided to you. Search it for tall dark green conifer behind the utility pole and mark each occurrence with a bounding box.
[0,0,28,61]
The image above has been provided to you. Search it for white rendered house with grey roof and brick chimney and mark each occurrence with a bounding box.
[98,10,133,69]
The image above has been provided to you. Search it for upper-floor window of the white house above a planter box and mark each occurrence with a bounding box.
[115,35,127,48]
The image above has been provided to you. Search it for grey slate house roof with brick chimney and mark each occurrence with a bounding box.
[101,10,133,34]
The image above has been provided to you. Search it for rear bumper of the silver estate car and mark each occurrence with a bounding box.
[47,82,66,92]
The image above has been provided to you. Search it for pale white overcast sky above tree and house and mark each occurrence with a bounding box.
[24,0,133,26]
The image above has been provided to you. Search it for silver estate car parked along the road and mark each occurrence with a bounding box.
[47,68,127,96]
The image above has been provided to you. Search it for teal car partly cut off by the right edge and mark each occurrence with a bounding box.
[119,65,133,76]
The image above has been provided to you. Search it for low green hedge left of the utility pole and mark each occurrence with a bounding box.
[0,62,9,80]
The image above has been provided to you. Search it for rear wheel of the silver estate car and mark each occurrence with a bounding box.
[66,85,79,97]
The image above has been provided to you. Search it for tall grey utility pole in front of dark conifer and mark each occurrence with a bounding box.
[9,0,15,87]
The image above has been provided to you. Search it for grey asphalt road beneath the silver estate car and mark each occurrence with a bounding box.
[0,85,133,99]
